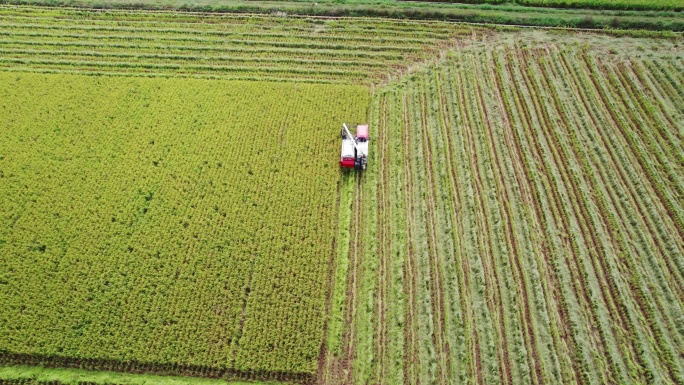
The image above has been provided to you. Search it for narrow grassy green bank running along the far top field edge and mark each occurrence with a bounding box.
[0,0,684,32]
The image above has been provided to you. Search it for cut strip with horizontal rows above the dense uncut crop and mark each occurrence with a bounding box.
[0,6,474,84]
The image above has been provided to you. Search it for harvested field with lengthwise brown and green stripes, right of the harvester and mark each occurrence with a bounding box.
[320,35,684,384]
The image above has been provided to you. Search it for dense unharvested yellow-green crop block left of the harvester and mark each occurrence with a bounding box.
[0,72,369,380]
